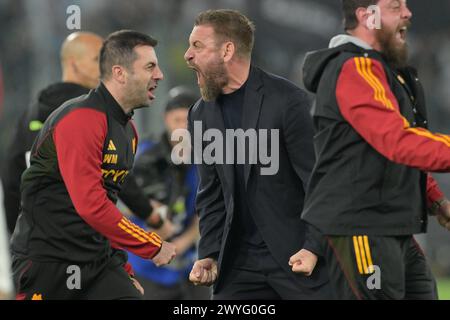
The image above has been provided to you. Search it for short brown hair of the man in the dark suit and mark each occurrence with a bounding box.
[195,9,255,58]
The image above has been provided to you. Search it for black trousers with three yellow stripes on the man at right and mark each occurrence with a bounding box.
[325,235,438,300]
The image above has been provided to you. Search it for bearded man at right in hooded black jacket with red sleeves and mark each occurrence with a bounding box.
[299,0,450,299]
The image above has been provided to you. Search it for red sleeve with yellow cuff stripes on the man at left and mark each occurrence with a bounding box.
[53,108,162,259]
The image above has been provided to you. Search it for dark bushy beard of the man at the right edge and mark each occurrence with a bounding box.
[376,24,408,68]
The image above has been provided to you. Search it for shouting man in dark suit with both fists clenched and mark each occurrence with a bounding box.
[185,10,331,299]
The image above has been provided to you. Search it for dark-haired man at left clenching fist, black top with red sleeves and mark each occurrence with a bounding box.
[12,31,175,299]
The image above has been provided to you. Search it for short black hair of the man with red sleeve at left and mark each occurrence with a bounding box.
[99,30,158,80]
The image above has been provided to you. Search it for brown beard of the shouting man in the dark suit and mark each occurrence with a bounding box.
[200,61,228,101]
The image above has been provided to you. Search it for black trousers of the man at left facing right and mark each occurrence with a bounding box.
[12,252,142,300]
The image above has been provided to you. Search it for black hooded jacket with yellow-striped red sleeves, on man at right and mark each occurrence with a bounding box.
[302,35,450,236]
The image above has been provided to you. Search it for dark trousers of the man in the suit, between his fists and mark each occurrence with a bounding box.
[213,248,333,300]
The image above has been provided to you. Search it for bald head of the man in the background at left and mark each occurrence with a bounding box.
[61,32,103,88]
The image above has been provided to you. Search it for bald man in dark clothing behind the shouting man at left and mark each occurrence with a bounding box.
[2,32,103,234]
